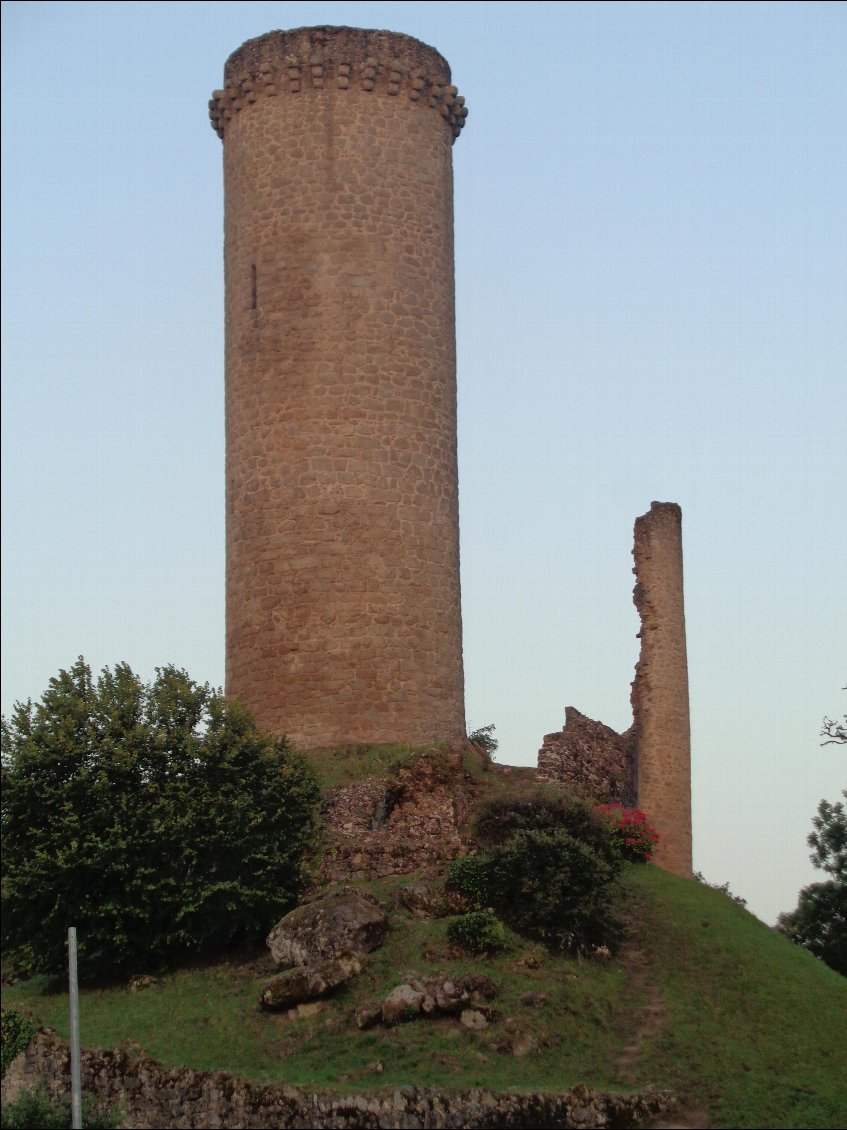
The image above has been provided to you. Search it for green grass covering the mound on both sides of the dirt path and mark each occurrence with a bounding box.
[3,866,847,1128]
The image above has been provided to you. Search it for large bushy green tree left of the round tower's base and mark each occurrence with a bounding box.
[2,658,318,977]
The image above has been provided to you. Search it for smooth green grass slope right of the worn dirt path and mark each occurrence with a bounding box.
[628,868,847,1128]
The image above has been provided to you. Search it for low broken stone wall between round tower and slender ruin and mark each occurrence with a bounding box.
[538,706,636,808]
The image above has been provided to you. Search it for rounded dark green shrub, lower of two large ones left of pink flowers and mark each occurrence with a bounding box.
[488,828,620,953]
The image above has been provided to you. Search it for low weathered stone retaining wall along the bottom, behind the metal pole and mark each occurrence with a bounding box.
[2,1033,675,1130]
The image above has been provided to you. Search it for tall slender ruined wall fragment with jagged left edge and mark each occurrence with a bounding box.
[630,502,691,878]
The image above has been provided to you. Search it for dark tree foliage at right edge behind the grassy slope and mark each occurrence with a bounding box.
[777,790,847,976]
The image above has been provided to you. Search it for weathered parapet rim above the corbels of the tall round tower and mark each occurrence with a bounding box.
[224,25,451,84]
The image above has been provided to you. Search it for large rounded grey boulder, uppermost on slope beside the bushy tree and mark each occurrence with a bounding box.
[268,887,388,966]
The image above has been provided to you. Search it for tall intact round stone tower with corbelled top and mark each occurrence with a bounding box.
[210,27,466,748]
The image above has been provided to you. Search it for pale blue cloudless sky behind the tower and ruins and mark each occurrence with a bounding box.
[2,2,847,920]
